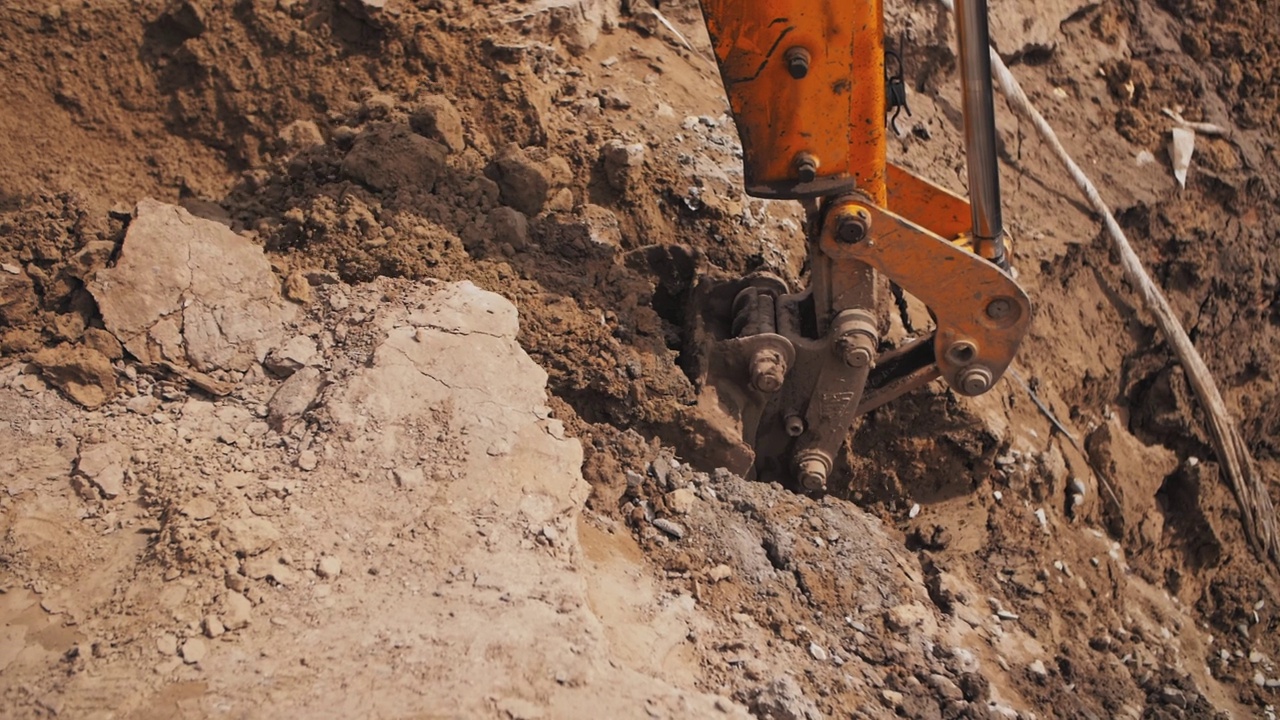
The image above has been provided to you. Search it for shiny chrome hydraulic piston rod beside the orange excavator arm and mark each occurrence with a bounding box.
[955,0,1005,243]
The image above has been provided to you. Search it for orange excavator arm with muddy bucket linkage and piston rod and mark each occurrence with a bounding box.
[692,0,1032,492]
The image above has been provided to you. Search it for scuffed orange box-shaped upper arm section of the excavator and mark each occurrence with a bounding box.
[701,0,884,198]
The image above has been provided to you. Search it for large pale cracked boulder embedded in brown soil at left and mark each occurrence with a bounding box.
[88,200,294,373]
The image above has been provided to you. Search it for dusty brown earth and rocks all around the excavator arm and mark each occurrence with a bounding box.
[0,0,1280,720]
